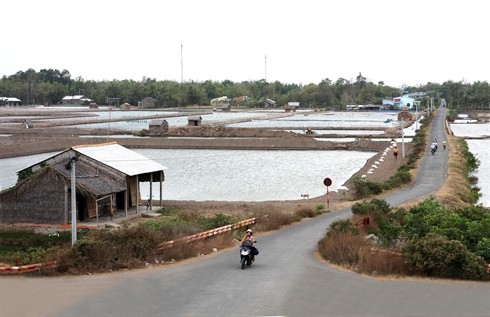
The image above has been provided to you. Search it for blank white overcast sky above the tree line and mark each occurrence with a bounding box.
[0,0,490,87]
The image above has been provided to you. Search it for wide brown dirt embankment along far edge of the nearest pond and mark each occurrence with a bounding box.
[0,126,388,158]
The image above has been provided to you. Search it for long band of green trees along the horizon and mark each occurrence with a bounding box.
[0,69,490,109]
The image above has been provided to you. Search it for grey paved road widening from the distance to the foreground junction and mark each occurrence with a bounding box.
[0,107,490,317]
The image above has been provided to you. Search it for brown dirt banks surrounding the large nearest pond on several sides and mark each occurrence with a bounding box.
[0,113,409,213]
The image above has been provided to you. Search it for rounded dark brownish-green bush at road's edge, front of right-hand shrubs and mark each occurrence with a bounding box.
[402,233,489,280]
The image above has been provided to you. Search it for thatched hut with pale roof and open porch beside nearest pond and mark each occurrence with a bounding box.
[0,142,166,224]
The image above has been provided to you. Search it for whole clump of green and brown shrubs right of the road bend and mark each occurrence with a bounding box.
[319,198,490,280]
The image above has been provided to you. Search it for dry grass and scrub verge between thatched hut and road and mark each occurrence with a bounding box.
[0,204,328,275]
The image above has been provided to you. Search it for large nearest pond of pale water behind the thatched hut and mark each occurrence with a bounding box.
[0,149,376,201]
